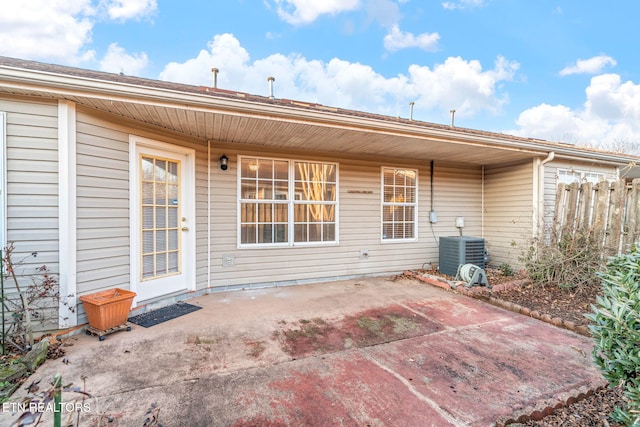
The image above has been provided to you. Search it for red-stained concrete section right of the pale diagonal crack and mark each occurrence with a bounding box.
[368,313,601,425]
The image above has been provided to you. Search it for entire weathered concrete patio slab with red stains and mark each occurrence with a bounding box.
[0,277,604,426]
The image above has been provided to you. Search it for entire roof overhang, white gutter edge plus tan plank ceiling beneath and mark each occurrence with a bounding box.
[0,57,629,169]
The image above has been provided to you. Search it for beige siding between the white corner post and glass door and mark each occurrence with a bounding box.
[76,115,129,295]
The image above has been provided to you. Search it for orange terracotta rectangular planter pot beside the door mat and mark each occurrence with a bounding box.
[80,288,136,331]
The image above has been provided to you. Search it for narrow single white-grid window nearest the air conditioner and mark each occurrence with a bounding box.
[382,167,418,241]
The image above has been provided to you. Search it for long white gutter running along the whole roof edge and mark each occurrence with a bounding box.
[0,65,640,165]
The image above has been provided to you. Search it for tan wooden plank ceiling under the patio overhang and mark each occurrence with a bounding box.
[0,90,540,165]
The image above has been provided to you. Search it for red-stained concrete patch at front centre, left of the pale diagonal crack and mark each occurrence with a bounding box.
[233,351,454,426]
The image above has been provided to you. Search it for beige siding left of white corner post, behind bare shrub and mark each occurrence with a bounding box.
[0,97,59,331]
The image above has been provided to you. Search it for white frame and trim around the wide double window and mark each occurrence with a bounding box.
[236,155,340,249]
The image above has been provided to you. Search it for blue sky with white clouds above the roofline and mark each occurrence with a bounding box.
[0,0,640,150]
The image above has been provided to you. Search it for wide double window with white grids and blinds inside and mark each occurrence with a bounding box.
[239,157,338,246]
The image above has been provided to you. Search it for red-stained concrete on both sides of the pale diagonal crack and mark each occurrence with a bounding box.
[232,298,602,426]
